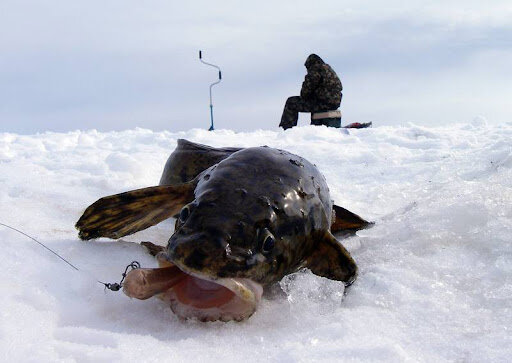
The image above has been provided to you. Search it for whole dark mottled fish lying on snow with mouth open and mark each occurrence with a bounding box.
[76,139,372,321]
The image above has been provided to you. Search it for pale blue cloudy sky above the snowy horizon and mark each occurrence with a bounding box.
[0,0,512,133]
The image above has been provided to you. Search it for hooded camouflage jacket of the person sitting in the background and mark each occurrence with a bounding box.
[300,54,343,108]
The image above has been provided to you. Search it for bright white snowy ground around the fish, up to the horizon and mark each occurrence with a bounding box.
[0,120,512,362]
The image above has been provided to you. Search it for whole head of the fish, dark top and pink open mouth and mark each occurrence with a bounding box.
[159,186,292,321]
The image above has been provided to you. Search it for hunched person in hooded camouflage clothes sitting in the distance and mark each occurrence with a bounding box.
[279,54,343,130]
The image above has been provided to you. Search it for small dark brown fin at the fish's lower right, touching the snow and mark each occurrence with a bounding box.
[306,233,357,286]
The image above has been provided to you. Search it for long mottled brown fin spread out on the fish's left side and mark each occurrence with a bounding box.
[75,181,196,240]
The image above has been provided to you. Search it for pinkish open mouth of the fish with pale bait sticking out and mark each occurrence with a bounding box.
[123,262,263,321]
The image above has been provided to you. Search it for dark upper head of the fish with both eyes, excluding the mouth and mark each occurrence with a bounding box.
[163,190,292,284]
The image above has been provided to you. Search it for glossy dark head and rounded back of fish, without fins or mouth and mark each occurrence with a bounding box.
[162,147,332,284]
